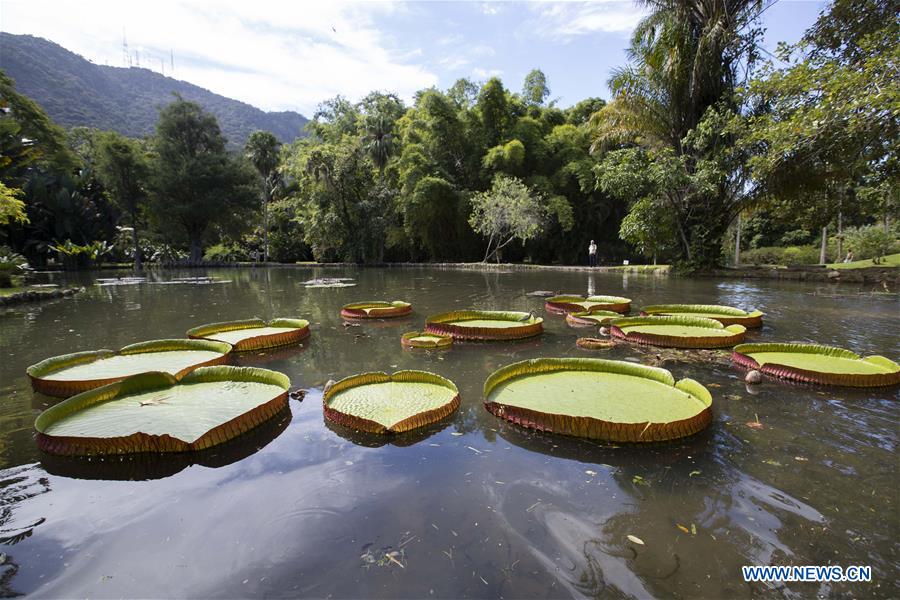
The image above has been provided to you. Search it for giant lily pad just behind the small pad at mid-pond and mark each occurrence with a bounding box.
[425,310,544,340]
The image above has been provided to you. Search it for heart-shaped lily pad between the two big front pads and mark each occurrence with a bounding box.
[322,371,459,433]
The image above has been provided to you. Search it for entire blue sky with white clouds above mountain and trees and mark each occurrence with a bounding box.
[0,0,825,116]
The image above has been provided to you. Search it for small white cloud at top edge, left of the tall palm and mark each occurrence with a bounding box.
[528,0,644,42]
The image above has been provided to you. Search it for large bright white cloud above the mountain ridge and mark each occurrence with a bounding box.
[0,0,438,116]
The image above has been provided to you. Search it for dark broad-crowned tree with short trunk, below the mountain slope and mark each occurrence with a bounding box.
[151,98,259,262]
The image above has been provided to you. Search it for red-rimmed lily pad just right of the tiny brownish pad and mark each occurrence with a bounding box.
[610,317,747,348]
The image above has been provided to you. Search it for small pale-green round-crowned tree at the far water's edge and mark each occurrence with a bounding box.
[469,175,547,262]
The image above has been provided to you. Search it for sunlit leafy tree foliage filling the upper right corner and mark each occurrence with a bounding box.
[736,0,900,234]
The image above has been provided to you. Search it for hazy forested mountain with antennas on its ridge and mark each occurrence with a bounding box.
[0,32,308,148]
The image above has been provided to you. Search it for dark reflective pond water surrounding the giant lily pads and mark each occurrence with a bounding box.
[0,267,900,598]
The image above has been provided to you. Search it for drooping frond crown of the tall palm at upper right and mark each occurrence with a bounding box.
[592,0,771,154]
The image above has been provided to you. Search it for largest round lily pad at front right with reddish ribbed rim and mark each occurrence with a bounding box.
[484,358,712,442]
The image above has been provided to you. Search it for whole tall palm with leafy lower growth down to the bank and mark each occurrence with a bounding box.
[591,0,765,269]
